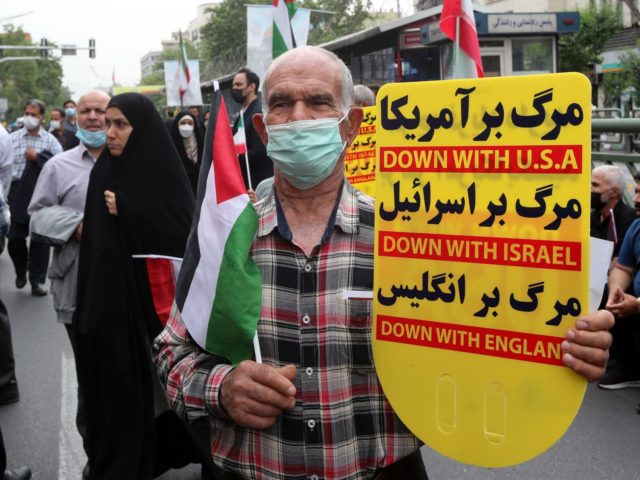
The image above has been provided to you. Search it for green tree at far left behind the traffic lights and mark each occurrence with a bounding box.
[0,24,69,119]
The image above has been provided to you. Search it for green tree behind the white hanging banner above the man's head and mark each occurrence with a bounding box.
[200,0,371,78]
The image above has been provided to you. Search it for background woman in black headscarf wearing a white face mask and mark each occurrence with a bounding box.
[170,112,203,195]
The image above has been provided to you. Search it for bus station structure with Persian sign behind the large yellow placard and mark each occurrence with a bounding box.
[323,6,579,85]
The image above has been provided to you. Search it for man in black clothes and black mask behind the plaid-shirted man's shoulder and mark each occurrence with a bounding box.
[231,68,273,190]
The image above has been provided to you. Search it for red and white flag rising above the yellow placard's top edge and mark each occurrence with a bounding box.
[440,0,484,78]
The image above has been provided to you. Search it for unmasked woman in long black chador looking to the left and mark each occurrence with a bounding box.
[74,93,208,480]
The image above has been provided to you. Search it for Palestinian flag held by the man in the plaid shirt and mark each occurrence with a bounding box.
[176,85,262,365]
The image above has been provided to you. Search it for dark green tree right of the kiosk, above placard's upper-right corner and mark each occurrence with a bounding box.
[558,2,622,73]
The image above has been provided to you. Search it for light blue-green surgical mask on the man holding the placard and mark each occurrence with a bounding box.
[266,114,347,190]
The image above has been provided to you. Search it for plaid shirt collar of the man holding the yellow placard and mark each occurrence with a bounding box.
[256,180,360,242]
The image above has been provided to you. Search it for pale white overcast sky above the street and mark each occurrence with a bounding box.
[0,0,413,100]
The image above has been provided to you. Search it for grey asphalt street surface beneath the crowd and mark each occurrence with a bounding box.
[0,252,640,480]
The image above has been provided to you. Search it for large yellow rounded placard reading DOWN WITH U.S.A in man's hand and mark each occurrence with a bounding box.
[373,73,591,467]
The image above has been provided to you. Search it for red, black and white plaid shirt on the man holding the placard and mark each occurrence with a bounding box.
[154,182,420,480]
